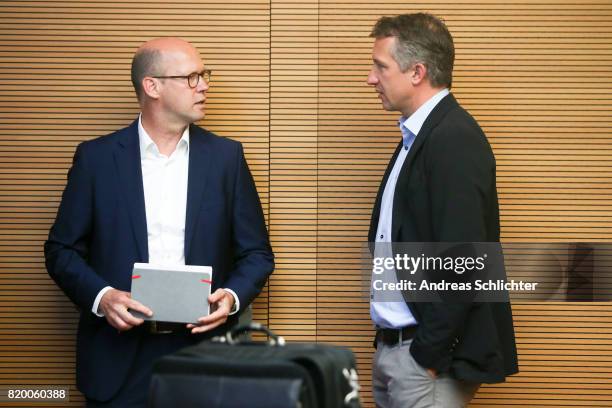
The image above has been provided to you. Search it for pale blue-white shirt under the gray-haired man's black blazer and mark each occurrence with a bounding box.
[370,88,450,329]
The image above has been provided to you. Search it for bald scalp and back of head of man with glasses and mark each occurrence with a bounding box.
[132,37,198,101]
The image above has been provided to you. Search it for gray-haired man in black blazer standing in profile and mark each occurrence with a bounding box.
[367,13,518,408]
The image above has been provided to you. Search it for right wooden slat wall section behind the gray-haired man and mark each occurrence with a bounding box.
[317,0,612,407]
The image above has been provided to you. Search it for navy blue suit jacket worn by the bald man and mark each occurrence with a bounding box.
[45,121,274,400]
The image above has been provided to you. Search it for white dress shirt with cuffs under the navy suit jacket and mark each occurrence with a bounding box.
[92,117,240,316]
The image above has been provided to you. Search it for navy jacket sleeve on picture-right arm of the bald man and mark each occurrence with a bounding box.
[224,144,274,309]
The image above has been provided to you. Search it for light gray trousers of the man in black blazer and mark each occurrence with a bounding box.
[372,340,480,408]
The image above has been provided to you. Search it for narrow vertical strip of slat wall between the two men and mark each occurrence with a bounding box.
[269,0,318,341]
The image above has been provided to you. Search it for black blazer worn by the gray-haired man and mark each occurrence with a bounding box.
[368,94,518,383]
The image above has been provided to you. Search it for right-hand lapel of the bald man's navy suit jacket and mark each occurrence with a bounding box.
[185,126,211,262]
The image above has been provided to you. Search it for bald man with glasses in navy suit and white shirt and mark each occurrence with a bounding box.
[45,38,274,407]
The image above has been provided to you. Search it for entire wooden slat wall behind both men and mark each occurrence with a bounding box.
[0,0,612,407]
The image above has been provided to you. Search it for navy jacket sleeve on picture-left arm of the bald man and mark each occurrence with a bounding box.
[44,144,108,310]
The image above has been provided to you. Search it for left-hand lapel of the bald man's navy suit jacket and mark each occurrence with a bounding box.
[115,120,149,262]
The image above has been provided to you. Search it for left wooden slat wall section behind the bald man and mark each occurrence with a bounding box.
[0,0,270,406]
